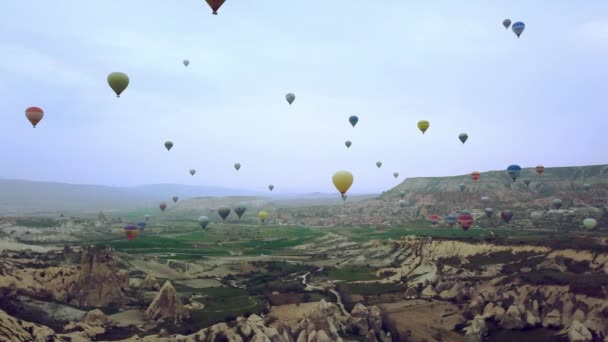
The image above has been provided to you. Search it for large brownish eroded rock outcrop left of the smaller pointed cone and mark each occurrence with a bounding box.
[72,246,129,307]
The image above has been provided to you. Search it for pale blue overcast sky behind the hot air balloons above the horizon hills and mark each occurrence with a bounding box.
[0,0,608,193]
